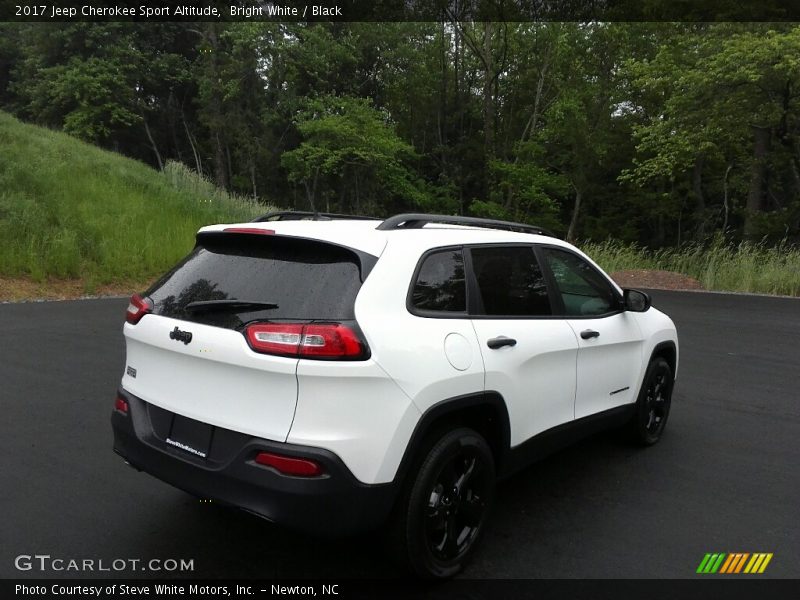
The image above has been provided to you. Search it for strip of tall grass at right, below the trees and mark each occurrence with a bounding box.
[581,238,800,296]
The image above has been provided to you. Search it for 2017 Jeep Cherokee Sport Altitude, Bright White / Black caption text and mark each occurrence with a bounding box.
[14,3,342,19]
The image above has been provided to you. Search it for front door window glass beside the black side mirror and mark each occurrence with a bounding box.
[542,248,619,317]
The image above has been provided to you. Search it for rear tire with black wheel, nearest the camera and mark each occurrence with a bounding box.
[391,428,495,579]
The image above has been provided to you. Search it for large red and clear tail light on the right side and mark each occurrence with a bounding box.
[245,323,367,360]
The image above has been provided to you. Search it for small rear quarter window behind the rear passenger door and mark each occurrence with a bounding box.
[411,249,467,313]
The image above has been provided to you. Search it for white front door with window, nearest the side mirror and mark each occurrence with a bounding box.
[539,246,643,419]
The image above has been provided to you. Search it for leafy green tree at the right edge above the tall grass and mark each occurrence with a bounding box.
[625,24,800,238]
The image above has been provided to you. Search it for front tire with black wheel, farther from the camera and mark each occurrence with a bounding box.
[627,357,675,446]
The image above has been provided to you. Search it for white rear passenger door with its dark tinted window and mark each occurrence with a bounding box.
[468,244,578,446]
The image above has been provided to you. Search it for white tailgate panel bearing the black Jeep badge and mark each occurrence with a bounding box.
[122,315,297,442]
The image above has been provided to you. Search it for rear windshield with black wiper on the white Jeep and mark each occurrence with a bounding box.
[147,234,371,329]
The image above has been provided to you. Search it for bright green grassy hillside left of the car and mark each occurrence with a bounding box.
[0,112,270,288]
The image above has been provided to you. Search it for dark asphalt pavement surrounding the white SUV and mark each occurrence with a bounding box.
[0,291,800,578]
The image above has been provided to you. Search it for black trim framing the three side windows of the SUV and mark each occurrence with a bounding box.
[406,242,625,321]
